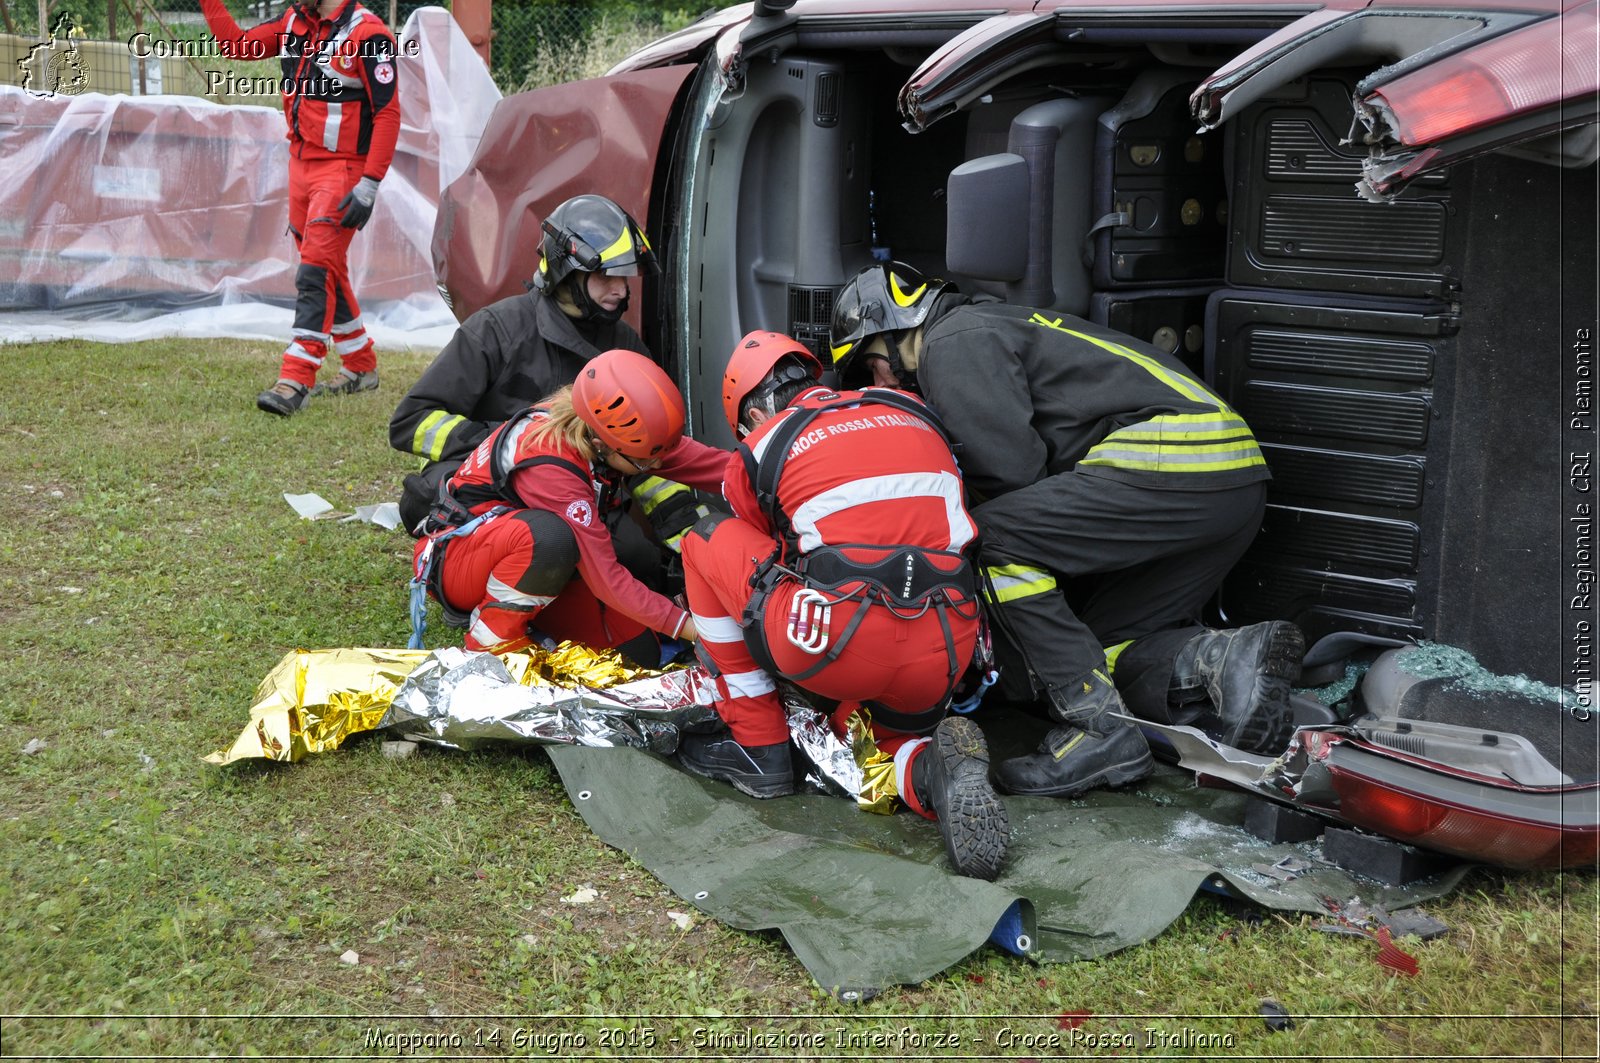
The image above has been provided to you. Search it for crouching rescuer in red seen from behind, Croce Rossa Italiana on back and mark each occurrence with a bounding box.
[678,333,1008,879]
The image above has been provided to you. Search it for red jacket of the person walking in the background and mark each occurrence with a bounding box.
[200,0,400,181]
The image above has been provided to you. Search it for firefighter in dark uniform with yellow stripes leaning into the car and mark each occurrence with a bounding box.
[832,263,1304,796]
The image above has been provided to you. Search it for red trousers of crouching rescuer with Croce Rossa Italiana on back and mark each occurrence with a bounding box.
[683,517,978,752]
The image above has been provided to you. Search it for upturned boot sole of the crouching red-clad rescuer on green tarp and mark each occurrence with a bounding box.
[910,716,1011,879]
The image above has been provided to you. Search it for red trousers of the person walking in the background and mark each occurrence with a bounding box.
[278,155,378,387]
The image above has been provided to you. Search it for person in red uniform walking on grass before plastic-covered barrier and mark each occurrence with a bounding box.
[200,0,400,416]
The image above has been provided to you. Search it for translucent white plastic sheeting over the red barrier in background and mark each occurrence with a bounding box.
[0,8,499,349]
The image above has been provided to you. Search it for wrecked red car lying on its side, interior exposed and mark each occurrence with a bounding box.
[434,0,1600,866]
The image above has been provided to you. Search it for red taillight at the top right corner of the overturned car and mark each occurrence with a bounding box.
[1370,3,1600,147]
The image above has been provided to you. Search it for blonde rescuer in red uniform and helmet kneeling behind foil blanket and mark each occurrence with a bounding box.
[416,351,728,664]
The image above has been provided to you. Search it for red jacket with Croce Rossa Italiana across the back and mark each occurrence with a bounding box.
[723,387,978,554]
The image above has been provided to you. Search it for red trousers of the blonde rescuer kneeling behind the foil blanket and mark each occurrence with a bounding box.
[416,509,645,653]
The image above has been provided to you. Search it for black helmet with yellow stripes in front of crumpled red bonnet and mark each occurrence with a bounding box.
[533,195,661,320]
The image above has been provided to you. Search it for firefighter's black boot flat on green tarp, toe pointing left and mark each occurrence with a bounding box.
[995,671,1155,797]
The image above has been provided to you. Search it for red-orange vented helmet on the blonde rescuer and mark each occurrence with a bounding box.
[573,351,683,458]
